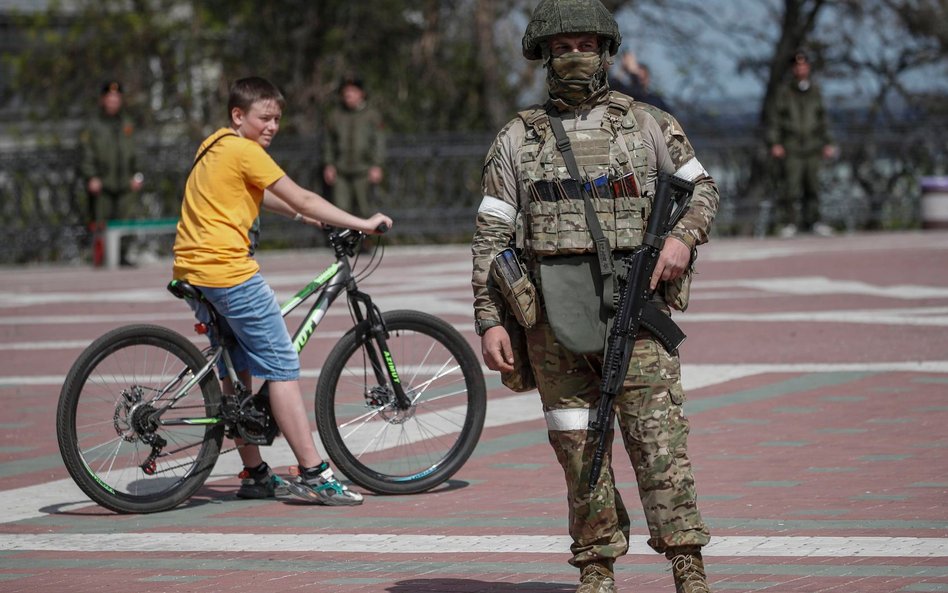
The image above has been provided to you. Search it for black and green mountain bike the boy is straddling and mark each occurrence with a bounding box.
[56,229,486,513]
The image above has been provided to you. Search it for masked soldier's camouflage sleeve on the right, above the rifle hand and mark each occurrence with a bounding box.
[640,104,720,250]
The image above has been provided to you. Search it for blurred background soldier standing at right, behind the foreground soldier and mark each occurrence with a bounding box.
[767,52,836,237]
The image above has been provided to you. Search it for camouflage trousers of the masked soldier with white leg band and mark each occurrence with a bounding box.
[527,320,710,566]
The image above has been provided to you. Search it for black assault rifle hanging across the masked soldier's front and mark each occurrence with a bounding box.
[589,173,695,490]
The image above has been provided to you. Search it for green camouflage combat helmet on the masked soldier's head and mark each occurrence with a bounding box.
[522,0,622,60]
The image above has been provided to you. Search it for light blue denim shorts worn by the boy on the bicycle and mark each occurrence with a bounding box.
[188,273,300,381]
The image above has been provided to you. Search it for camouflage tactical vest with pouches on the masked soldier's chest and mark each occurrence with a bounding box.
[517,93,651,256]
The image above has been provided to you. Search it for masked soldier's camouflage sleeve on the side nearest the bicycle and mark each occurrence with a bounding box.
[471,119,523,324]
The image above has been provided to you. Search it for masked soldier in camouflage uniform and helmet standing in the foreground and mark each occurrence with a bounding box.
[472,0,718,593]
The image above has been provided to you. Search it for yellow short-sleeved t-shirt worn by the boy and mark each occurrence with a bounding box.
[174,128,285,288]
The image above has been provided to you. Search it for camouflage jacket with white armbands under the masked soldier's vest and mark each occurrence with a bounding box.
[471,91,719,328]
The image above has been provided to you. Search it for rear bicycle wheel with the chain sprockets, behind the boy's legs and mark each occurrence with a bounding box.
[56,325,224,513]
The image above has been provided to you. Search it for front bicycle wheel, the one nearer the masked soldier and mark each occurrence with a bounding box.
[316,310,487,494]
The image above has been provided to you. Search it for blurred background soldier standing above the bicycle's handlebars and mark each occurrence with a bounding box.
[323,77,385,216]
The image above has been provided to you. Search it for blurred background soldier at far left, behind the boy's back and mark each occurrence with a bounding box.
[79,81,144,266]
